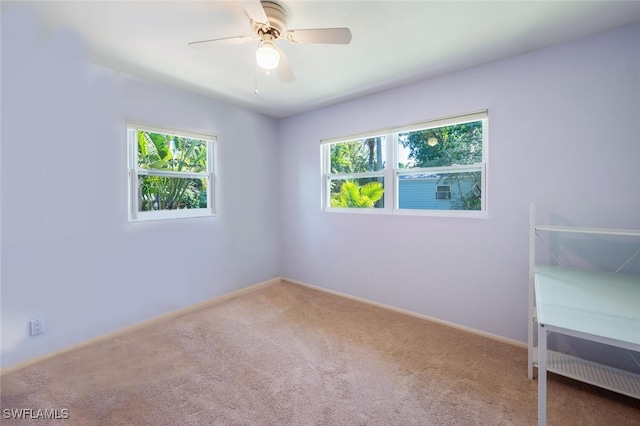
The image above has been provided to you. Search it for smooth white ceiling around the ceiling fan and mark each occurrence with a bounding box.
[11,0,640,118]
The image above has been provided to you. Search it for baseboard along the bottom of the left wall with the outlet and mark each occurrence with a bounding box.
[0,277,282,377]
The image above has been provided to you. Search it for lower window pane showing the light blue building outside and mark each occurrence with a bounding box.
[398,171,482,210]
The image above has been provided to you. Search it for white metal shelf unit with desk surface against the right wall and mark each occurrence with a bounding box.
[528,204,640,425]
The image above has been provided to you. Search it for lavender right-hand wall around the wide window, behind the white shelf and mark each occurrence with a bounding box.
[279,24,640,342]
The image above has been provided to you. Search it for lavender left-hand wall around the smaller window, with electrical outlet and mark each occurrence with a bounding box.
[1,8,279,366]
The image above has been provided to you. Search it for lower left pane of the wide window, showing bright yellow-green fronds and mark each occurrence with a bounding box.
[329,177,384,208]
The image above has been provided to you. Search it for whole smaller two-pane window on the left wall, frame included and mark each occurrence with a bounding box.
[127,123,215,221]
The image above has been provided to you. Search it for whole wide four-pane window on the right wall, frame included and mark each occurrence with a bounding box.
[321,111,488,217]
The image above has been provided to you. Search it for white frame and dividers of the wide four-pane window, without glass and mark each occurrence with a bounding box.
[320,110,489,218]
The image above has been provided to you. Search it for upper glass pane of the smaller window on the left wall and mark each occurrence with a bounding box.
[137,130,207,172]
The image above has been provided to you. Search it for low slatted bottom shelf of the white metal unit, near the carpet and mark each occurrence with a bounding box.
[533,347,640,399]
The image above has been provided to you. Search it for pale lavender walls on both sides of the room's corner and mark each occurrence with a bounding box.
[0,4,640,366]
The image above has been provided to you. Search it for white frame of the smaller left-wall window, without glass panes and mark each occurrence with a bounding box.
[126,121,217,222]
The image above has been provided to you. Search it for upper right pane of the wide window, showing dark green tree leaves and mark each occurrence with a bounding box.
[398,121,482,169]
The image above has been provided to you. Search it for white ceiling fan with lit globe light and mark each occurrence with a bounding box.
[189,0,351,83]
